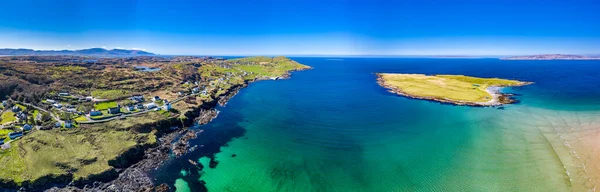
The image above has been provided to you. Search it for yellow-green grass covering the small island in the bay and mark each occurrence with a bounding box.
[378,73,527,102]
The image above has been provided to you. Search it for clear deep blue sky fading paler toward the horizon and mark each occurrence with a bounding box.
[0,0,600,55]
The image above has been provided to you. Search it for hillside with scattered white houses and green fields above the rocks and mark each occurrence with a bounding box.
[0,56,309,185]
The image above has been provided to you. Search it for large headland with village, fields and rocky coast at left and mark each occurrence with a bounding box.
[0,55,310,191]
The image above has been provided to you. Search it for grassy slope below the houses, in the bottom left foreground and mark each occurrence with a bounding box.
[0,127,155,183]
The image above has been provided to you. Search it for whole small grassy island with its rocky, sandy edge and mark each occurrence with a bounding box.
[377,73,531,106]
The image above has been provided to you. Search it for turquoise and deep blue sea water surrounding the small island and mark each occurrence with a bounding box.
[154,58,600,192]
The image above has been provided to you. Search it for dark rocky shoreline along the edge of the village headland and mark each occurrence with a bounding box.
[45,67,312,192]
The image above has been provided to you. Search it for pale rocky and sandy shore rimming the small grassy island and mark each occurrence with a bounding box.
[377,74,532,107]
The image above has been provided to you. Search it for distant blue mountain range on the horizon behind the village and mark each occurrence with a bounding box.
[0,48,156,57]
